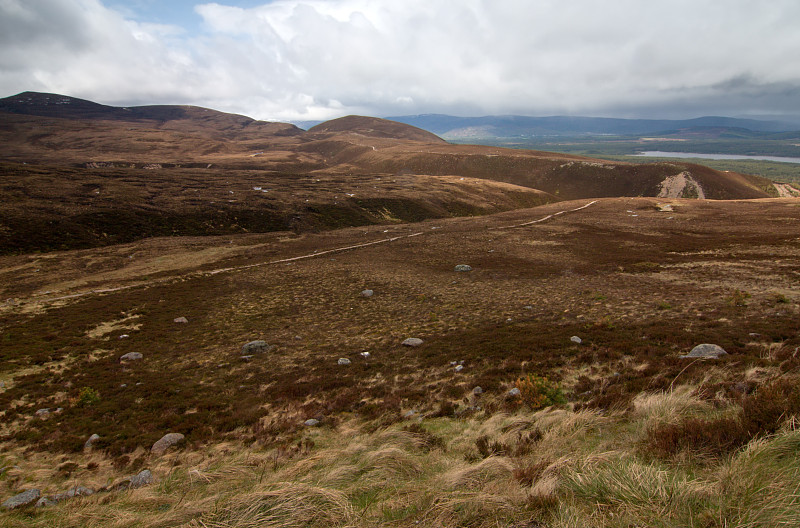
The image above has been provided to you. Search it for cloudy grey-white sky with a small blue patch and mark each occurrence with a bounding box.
[0,0,800,121]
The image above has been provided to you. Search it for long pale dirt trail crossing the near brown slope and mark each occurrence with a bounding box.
[0,200,597,308]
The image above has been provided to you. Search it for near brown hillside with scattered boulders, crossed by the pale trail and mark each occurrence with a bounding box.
[0,198,800,528]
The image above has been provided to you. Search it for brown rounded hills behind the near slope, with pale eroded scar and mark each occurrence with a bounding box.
[0,89,794,253]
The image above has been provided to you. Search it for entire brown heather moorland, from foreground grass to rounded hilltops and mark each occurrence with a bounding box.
[0,93,800,527]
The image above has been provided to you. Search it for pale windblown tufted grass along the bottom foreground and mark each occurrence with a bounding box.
[2,386,800,528]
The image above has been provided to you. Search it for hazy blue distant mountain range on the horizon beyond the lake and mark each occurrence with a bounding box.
[295,114,800,141]
